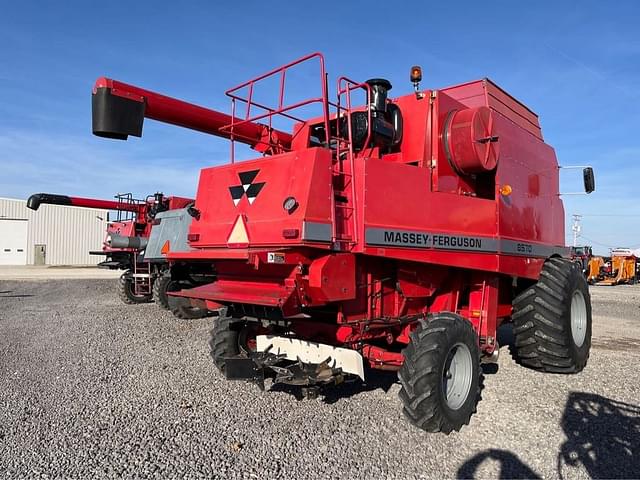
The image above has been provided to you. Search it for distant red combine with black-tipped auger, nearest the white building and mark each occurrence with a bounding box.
[27,193,193,308]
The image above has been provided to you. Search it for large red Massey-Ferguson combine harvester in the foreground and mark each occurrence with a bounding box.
[94,54,594,433]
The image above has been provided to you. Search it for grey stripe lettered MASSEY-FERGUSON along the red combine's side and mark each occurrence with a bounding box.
[365,227,570,258]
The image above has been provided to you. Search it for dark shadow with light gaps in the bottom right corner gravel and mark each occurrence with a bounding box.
[558,392,640,478]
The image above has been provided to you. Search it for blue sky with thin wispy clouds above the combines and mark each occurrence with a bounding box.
[0,0,640,253]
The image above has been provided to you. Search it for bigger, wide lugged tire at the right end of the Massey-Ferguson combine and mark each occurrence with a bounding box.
[512,258,591,373]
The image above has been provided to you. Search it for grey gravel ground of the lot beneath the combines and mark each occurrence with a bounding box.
[0,280,640,478]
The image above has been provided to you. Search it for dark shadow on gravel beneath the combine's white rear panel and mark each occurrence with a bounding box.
[269,370,398,405]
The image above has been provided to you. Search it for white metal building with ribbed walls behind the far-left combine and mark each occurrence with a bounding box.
[0,198,107,265]
